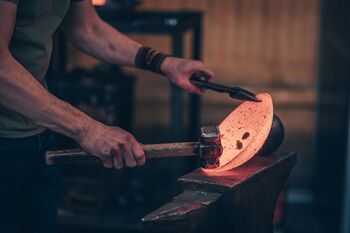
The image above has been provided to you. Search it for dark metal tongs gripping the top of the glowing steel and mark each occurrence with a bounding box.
[190,71,261,102]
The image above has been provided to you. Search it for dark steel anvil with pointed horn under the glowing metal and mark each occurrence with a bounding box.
[142,152,297,233]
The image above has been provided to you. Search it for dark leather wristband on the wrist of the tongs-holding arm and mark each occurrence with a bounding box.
[135,46,169,74]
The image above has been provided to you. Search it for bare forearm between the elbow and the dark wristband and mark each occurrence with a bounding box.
[66,18,141,66]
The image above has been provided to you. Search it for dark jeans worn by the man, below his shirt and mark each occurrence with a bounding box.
[0,130,59,233]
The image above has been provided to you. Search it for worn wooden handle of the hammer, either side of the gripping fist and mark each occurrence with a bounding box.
[45,142,199,165]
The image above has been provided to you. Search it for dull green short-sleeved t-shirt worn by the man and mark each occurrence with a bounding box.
[0,0,81,138]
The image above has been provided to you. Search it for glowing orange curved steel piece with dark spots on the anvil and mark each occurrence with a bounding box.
[204,93,273,173]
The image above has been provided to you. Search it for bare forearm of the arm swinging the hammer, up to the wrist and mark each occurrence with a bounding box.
[0,52,93,140]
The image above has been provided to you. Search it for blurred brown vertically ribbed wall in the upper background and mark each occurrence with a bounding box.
[141,0,319,85]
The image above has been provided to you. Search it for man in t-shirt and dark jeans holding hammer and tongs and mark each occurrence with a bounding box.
[0,0,213,233]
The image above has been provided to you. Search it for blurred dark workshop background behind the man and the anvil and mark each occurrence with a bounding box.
[48,0,350,233]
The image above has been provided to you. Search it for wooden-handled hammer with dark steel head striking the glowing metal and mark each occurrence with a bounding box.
[45,126,222,169]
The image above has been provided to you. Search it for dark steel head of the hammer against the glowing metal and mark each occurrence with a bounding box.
[199,126,222,169]
